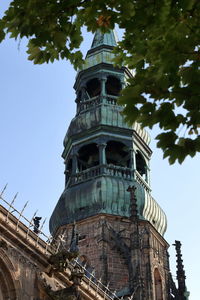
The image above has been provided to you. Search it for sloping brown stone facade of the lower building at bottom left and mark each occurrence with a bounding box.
[0,204,115,300]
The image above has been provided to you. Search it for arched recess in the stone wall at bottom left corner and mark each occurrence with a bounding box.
[0,256,17,300]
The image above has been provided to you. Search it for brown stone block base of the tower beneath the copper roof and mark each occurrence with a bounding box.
[55,215,170,300]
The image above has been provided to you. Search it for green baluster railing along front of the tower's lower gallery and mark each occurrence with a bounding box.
[69,165,133,186]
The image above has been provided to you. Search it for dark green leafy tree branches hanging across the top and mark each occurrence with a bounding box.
[0,0,200,164]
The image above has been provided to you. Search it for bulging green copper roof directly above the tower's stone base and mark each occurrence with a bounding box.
[49,175,167,235]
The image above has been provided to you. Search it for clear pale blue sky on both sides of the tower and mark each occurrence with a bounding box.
[0,0,200,300]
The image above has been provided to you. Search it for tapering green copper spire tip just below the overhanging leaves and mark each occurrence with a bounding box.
[91,30,117,49]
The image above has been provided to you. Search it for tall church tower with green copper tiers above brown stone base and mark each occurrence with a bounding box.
[50,31,172,300]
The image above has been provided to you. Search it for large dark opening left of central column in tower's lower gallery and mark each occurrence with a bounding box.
[78,143,99,171]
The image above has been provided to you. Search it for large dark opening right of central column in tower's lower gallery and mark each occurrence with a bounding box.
[106,141,130,168]
